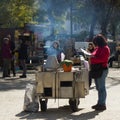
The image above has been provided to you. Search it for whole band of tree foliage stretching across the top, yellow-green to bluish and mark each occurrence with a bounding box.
[0,0,120,38]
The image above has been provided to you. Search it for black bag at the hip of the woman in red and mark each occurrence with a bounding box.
[89,64,103,79]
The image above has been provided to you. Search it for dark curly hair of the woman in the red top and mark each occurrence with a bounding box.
[93,34,107,47]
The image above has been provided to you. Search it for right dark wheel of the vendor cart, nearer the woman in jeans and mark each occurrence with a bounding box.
[69,99,80,112]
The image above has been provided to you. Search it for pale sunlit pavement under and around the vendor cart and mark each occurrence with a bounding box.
[0,68,120,120]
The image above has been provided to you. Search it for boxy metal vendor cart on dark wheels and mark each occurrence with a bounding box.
[36,66,89,111]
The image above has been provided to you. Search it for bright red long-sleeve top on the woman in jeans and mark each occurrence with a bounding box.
[90,45,110,67]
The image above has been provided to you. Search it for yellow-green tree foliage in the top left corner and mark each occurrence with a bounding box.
[0,0,36,27]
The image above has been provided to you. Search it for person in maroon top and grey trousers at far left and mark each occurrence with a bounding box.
[2,38,12,78]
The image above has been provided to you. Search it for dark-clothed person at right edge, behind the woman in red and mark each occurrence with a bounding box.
[108,44,120,67]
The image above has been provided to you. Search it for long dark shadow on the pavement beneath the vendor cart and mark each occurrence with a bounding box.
[16,107,99,120]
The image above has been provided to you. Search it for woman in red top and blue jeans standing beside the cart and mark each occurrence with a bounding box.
[90,34,110,110]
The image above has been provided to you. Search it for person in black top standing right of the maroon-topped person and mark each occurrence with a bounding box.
[19,40,28,78]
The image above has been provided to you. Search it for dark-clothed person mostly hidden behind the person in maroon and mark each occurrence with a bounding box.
[7,34,16,77]
